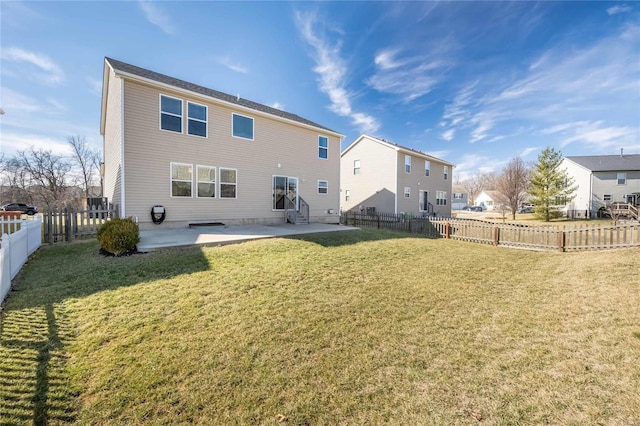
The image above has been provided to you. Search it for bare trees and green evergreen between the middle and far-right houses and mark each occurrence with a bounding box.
[459,147,576,222]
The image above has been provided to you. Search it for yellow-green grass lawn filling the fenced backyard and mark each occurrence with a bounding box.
[0,230,640,425]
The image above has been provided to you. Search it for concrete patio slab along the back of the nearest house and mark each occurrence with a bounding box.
[138,223,358,252]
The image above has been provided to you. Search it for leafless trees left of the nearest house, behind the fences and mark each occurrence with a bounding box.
[0,136,102,210]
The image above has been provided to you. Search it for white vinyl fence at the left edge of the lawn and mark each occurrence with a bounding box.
[0,216,42,303]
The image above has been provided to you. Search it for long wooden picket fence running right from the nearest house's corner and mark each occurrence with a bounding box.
[340,212,640,252]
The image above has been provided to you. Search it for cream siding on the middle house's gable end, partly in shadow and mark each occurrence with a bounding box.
[340,138,396,213]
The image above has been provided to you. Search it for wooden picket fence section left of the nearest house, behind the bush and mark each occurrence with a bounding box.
[42,209,116,244]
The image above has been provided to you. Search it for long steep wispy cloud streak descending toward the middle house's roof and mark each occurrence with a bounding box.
[295,12,380,133]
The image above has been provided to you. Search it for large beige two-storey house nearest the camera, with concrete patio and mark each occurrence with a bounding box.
[100,58,344,227]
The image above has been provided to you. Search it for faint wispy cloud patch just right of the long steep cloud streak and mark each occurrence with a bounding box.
[367,48,448,102]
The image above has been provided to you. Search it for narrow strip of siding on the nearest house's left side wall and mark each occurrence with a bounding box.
[103,69,122,215]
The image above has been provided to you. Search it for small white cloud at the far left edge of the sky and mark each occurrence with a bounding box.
[0,47,64,86]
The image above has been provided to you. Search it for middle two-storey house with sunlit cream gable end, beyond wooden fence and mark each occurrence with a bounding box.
[340,135,454,216]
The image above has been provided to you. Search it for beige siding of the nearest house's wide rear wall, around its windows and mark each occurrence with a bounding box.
[124,80,340,226]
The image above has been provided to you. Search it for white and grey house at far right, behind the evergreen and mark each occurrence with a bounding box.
[561,153,640,217]
